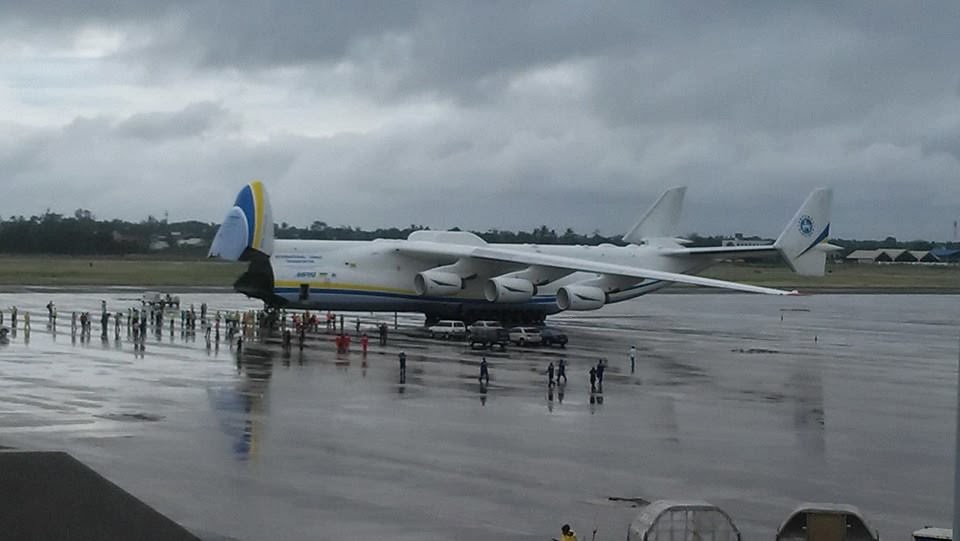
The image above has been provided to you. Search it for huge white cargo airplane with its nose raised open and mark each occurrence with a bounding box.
[209,181,835,322]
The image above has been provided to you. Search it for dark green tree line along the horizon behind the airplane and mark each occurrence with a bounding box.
[0,209,938,256]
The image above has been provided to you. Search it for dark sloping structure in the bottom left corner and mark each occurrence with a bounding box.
[0,450,199,541]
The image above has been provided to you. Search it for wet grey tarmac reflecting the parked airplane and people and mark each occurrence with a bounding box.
[0,290,960,540]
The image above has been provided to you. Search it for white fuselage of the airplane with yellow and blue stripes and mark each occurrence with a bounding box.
[258,240,711,318]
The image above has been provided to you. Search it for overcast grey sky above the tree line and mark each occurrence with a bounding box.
[0,0,960,240]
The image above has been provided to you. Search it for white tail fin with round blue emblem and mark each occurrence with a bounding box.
[773,188,833,276]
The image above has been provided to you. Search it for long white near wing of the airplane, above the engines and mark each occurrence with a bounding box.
[397,241,797,295]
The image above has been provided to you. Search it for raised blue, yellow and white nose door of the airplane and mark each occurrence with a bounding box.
[209,180,273,261]
